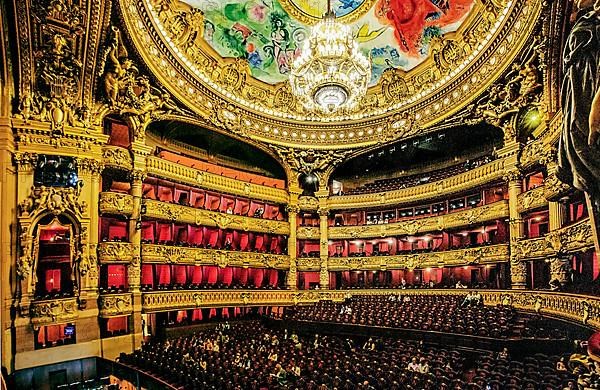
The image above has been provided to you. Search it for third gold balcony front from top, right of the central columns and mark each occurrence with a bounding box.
[326,244,509,271]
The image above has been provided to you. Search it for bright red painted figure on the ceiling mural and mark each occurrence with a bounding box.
[376,0,473,57]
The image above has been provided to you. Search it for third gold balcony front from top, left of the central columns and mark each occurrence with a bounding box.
[142,244,290,269]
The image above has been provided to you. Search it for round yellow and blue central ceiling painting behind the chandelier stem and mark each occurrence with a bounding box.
[279,0,377,25]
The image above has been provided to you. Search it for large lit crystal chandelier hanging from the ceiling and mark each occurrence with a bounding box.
[290,0,371,114]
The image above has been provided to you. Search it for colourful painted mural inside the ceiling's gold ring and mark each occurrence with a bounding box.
[183,0,475,85]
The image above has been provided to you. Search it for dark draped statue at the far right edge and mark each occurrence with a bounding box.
[557,0,600,248]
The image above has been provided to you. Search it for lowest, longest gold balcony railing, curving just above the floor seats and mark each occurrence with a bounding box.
[142,289,600,329]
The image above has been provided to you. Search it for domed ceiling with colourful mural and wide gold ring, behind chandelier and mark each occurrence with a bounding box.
[119,0,541,149]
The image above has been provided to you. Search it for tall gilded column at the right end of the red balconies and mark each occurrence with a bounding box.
[504,169,527,289]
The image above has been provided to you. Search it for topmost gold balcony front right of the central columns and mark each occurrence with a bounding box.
[328,159,505,210]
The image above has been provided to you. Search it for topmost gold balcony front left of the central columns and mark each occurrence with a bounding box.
[146,157,289,204]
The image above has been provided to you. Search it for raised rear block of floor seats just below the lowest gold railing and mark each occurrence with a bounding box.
[287,294,564,339]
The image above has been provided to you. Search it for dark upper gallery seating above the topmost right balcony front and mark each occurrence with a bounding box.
[344,156,493,195]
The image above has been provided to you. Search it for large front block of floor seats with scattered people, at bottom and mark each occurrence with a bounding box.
[119,321,575,390]
